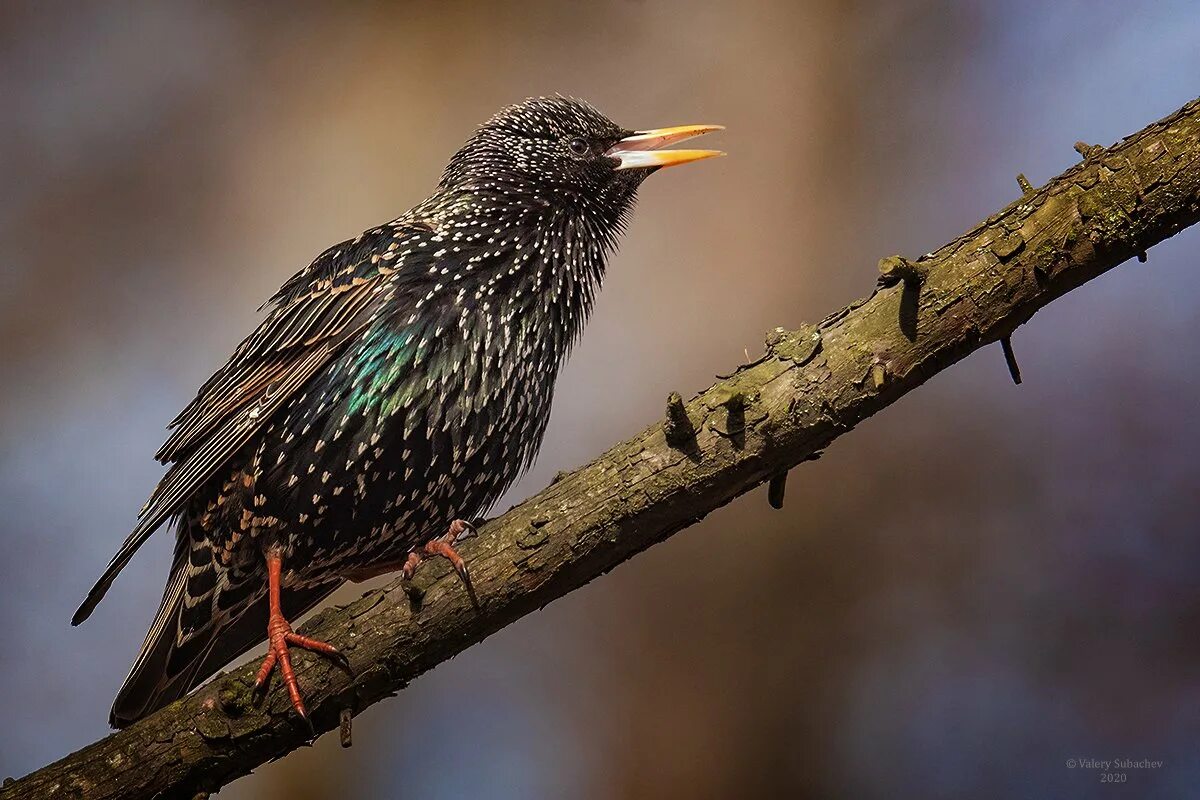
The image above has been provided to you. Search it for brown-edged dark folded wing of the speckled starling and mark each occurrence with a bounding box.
[72,221,430,625]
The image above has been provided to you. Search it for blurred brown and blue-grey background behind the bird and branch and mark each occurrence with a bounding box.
[0,0,1200,800]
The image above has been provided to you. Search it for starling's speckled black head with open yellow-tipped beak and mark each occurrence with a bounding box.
[442,97,724,234]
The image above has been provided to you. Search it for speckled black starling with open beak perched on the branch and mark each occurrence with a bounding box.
[72,96,724,728]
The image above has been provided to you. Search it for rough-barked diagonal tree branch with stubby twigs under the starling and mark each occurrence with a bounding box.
[9,100,1200,800]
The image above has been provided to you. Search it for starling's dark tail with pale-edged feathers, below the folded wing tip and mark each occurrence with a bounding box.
[109,527,342,728]
